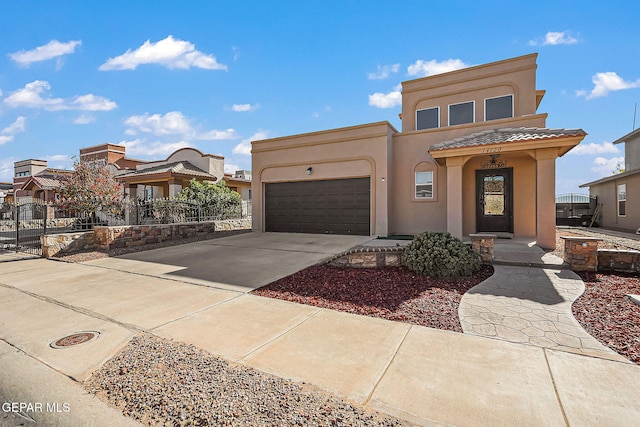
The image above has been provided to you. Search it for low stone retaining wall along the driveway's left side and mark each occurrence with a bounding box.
[41,218,251,258]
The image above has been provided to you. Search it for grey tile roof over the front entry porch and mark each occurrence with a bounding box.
[429,128,587,151]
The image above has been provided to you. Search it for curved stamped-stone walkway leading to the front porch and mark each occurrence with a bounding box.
[458,265,628,362]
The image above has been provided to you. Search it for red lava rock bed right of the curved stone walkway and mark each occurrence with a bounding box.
[572,272,640,365]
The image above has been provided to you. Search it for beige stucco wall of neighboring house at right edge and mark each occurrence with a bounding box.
[589,174,640,232]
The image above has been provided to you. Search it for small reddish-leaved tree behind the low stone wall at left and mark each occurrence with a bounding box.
[59,161,124,222]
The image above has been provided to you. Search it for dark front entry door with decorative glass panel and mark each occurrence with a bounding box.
[476,168,513,233]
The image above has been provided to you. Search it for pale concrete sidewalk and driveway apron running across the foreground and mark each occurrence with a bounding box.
[0,236,640,426]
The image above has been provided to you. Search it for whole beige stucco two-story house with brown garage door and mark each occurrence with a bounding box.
[252,54,586,248]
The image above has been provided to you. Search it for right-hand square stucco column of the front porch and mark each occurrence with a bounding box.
[536,148,558,249]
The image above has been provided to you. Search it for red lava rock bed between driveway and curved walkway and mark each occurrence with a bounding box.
[252,265,493,332]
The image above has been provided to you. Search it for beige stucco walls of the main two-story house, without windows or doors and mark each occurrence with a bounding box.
[252,54,579,247]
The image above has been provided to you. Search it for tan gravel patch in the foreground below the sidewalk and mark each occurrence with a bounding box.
[84,335,408,427]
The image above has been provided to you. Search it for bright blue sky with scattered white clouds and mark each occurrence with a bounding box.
[0,0,640,194]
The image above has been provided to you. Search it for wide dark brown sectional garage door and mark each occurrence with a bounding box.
[265,178,371,236]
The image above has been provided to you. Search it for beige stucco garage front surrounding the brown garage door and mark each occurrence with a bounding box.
[252,122,396,235]
